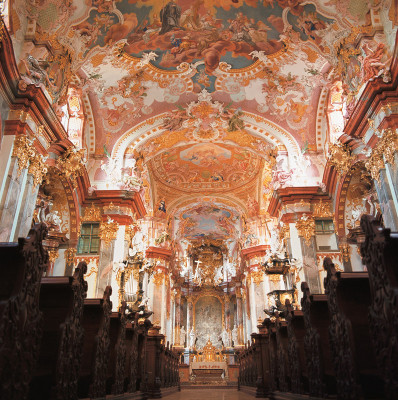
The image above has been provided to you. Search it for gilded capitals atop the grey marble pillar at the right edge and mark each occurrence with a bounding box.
[365,128,398,182]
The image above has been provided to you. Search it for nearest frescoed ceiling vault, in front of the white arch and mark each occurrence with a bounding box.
[11,0,390,155]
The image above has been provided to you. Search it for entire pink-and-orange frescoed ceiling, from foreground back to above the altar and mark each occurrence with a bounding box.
[9,0,395,239]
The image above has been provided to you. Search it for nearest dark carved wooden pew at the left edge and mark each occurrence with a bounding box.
[0,224,48,400]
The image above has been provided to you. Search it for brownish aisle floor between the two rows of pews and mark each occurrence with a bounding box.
[165,388,253,400]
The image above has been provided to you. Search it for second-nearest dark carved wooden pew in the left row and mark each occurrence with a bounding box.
[29,262,87,399]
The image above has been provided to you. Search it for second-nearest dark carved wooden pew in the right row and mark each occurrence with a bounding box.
[323,258,383,398]
